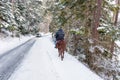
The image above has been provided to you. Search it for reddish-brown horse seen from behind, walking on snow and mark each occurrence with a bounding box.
[56,40,66,60]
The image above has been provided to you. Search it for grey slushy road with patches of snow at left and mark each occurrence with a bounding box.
[0,39,35,80]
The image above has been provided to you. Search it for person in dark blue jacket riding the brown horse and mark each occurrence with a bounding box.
[55,27,65,48]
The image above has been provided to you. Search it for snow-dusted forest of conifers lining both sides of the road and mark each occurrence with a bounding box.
[0,0,120,80]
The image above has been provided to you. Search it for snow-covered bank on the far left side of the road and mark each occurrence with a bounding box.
[0,36,33,55]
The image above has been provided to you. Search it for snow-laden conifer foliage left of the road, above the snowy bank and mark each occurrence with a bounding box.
[0,0,44,35]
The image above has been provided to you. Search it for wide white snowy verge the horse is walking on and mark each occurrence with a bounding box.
[9,34,103,80]
